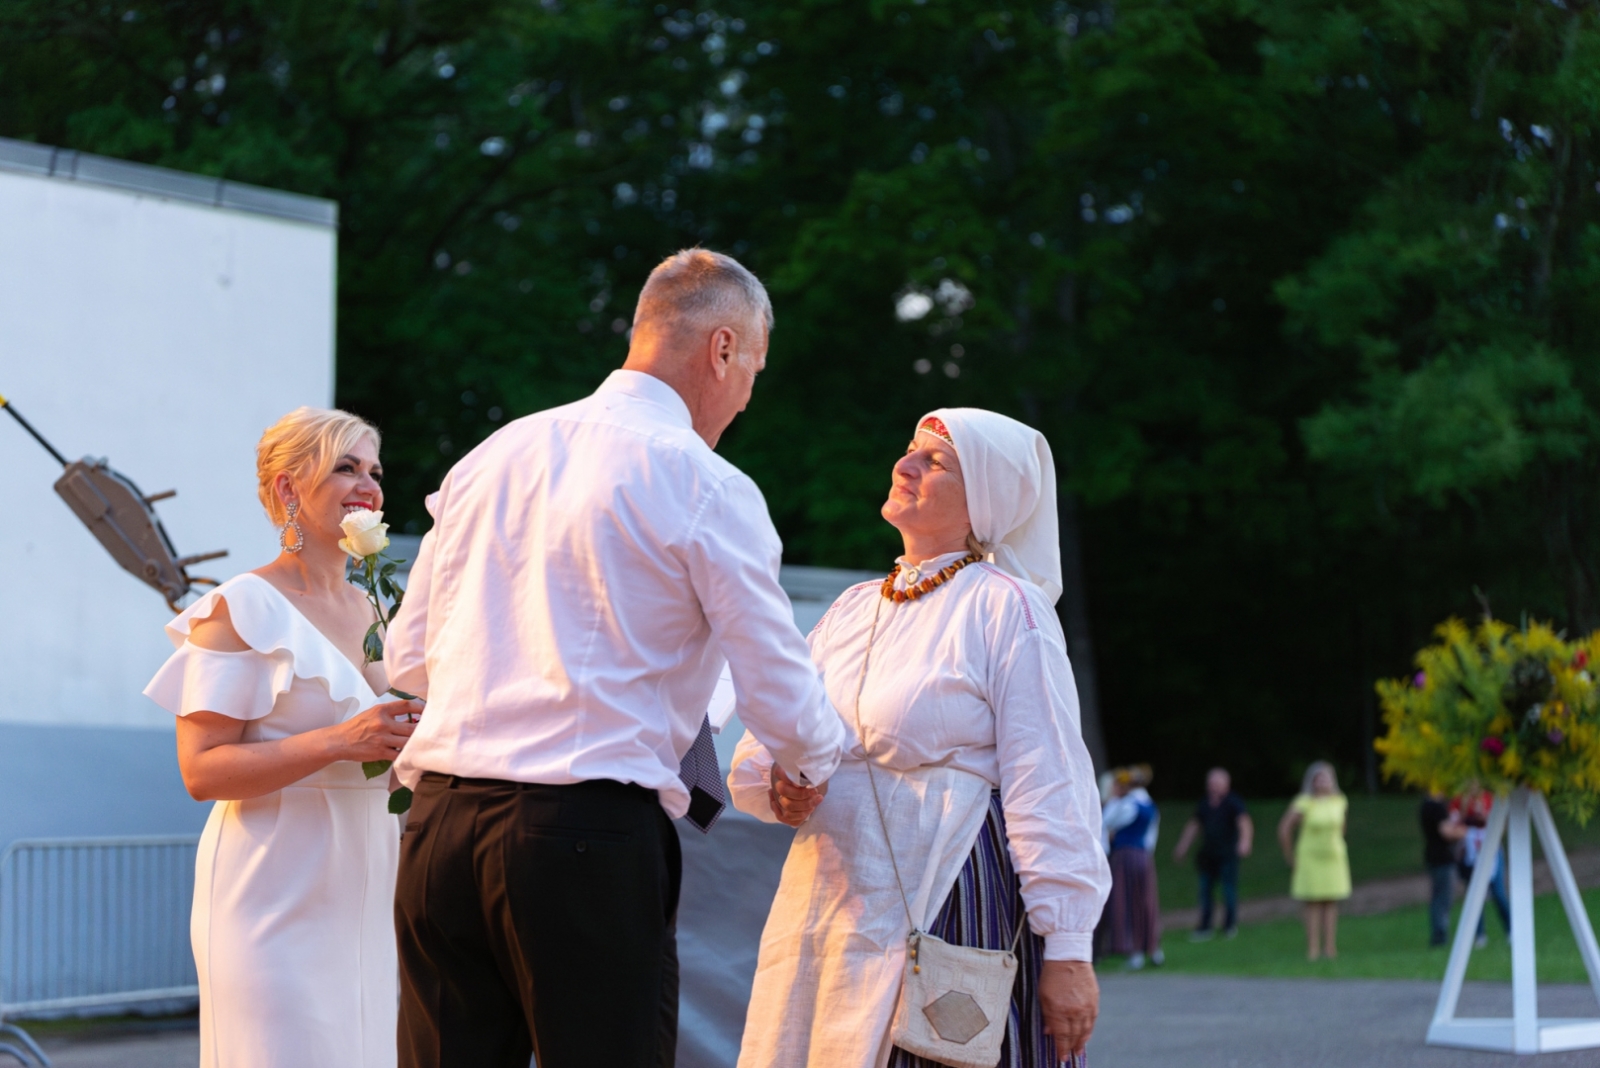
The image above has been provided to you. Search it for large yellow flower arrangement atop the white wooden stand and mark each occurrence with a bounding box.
[1376,619,1600,823]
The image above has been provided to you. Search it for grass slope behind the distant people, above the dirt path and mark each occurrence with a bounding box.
[1155,793,1600,908]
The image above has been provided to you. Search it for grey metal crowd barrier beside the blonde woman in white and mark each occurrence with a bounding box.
[0,835,200,1068]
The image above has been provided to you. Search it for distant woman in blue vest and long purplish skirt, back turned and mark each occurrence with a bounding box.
[1096,764,1166,969]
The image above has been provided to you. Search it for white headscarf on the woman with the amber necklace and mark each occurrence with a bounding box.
[917,408,1061,604]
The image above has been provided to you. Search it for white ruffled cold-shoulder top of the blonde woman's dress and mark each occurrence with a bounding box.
[144,574,376,719]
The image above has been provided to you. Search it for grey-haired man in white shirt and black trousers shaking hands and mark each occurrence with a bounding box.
[387,249,845,1068]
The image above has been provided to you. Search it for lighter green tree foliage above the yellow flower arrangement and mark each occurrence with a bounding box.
[1277,3,1600,630]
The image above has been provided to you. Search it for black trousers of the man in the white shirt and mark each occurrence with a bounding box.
[395,774,683,1068]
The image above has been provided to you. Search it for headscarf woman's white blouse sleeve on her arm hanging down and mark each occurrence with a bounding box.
[989,606,1131,961]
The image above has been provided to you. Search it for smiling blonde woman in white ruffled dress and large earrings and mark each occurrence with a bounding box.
[144,408,421,1068]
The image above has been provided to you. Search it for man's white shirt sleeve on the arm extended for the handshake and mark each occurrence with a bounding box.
[688,475,845,785]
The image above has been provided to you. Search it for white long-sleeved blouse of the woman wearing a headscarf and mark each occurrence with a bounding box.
[728,553,1110,961]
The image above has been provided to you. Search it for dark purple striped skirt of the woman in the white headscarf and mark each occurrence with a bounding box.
[888,790,1088,1068]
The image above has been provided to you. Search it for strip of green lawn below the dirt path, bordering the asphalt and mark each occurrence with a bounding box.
[1126,889,1600,983]
